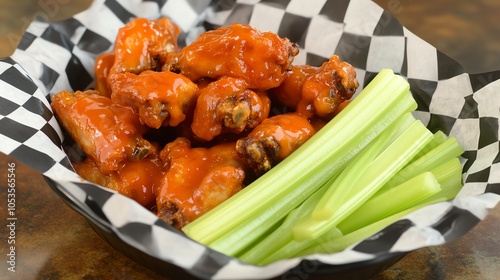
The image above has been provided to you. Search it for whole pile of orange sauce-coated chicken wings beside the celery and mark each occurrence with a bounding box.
[51,18,358,229]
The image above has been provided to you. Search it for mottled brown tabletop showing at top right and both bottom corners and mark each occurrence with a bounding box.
[0,0,500,280]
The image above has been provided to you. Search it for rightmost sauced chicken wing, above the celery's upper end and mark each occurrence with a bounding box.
[272,55,359,119]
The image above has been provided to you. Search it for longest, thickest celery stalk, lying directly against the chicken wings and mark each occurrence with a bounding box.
[183,69,416,247]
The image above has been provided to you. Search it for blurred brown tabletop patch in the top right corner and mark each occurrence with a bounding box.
[374,0,500,73]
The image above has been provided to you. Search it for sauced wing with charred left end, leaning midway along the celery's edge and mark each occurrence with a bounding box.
[236,113,315,175]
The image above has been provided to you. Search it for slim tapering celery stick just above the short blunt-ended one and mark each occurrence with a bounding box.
[381,137,464,192]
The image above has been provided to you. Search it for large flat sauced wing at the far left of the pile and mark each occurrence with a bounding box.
[51,90,152,173]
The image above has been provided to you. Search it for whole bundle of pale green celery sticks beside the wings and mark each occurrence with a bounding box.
[183,69,463,265]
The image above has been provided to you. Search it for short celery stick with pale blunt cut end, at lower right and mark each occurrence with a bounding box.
[337,172,441,234]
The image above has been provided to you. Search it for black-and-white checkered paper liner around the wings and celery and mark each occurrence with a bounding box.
[0,0,500,279]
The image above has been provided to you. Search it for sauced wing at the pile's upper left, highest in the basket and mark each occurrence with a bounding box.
[111,18,180,74]
